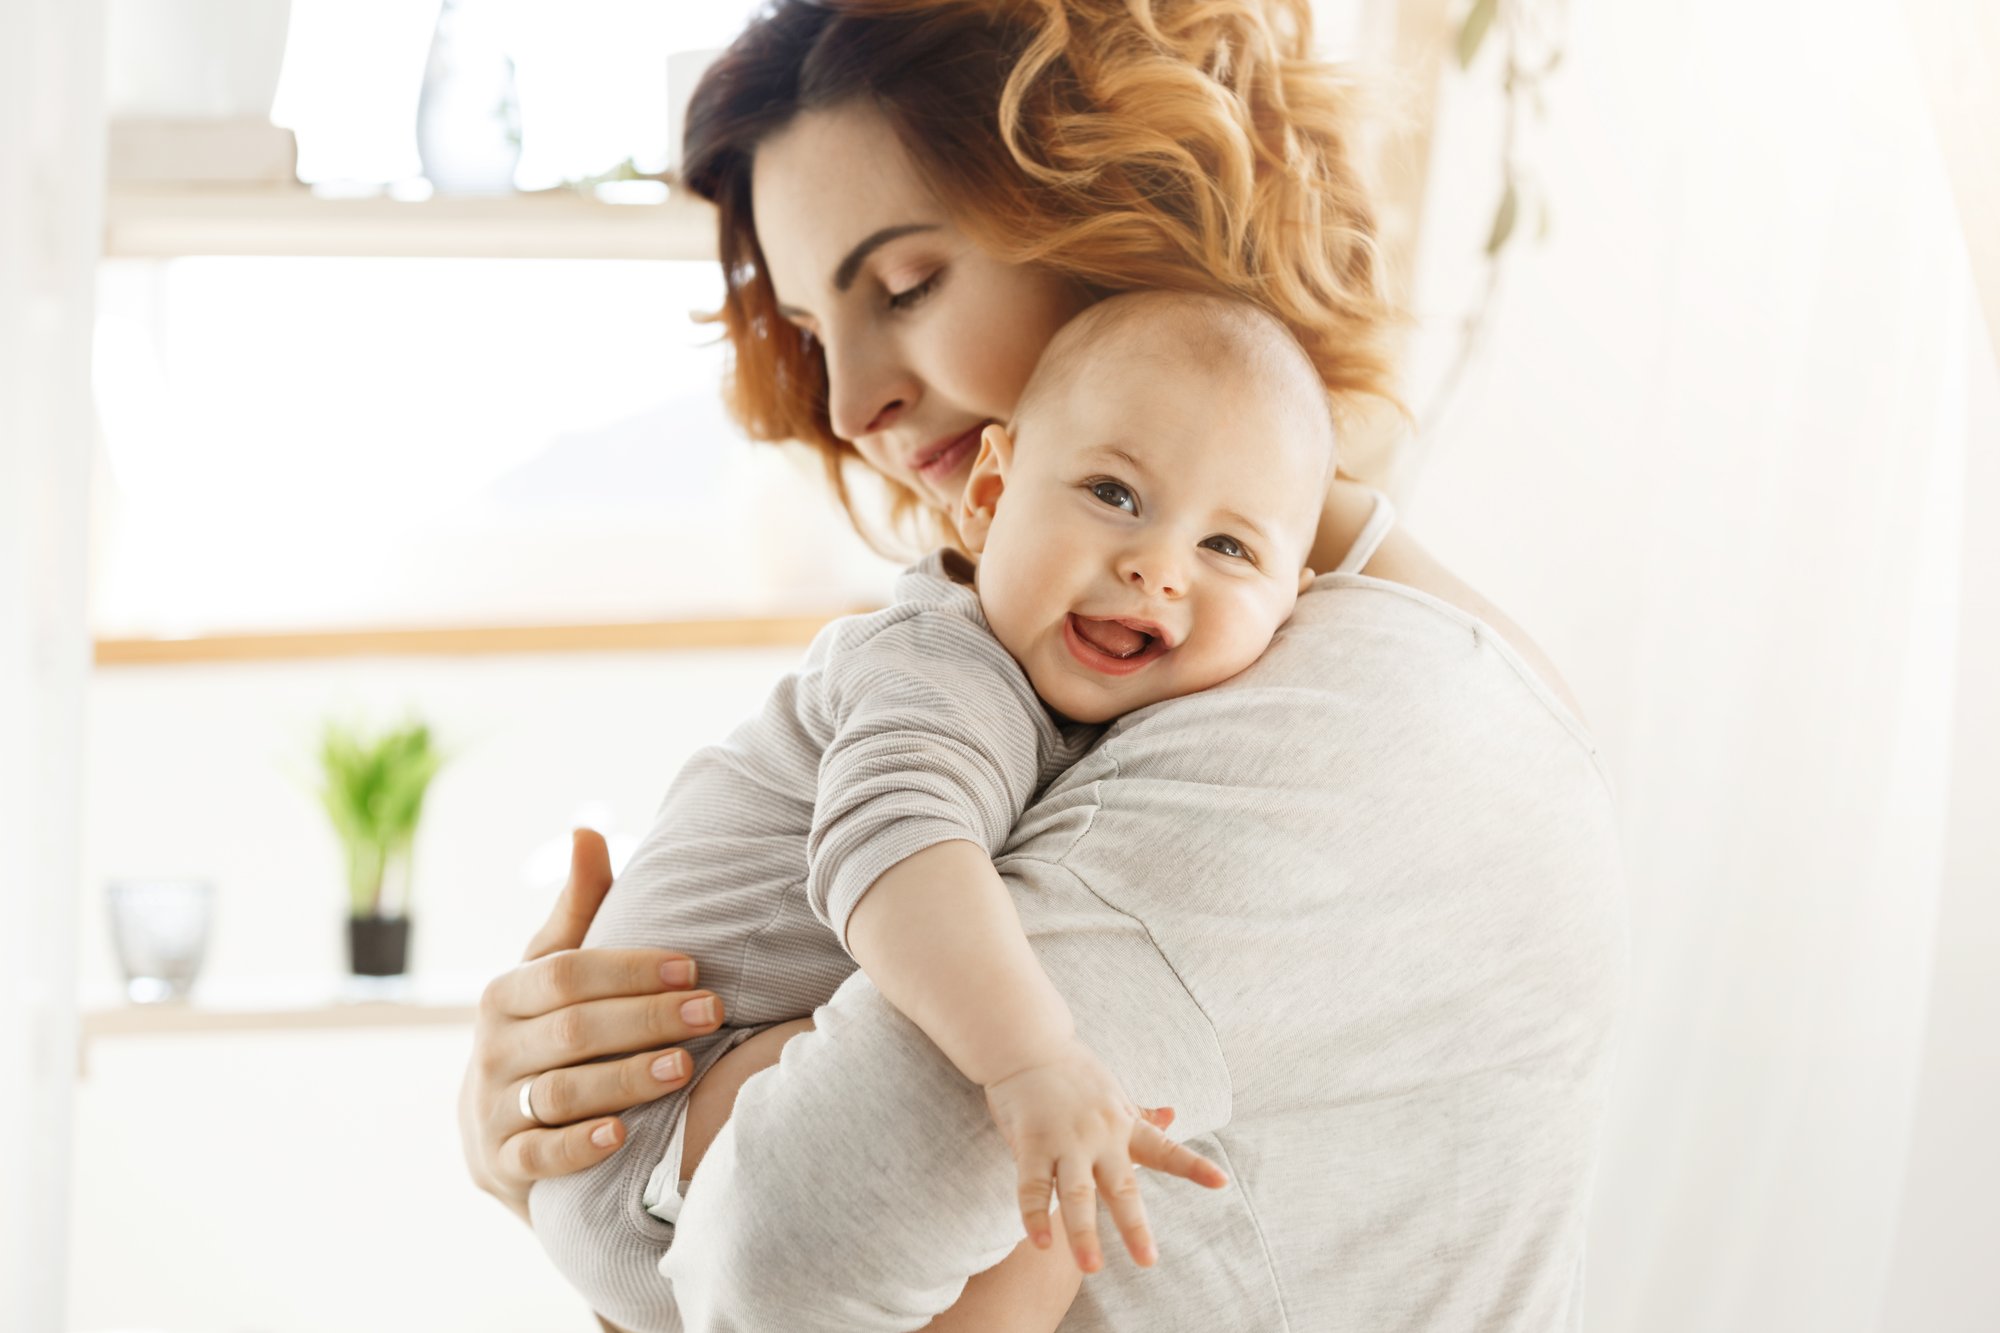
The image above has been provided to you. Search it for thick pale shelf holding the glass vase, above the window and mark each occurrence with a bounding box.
[104,186,716,260]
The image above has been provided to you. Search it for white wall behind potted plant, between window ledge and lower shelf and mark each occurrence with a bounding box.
[80,648,802,987]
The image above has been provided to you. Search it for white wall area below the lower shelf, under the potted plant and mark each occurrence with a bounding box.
[72,1029,598,1333]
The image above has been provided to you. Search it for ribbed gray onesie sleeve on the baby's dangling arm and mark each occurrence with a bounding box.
[806,608,1056,953]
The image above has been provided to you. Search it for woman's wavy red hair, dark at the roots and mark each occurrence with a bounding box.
[682,0,1398,544]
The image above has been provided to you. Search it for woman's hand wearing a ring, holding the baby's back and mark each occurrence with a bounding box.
[458,829,722,1221]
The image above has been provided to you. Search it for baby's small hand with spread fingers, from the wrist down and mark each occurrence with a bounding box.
[986,1039,1228,1273]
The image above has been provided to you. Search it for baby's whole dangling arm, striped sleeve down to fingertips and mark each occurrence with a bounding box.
[800,610,1222,1271]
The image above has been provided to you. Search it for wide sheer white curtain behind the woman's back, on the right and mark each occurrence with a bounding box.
[1402,0,2000,1333]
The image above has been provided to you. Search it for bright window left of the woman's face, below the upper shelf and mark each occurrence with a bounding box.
[92,258,894,636]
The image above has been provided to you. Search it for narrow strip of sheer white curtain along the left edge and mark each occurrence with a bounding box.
[0,0,104,1333]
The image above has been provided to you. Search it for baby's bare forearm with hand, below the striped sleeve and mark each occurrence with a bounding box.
[846,841,1226,1273]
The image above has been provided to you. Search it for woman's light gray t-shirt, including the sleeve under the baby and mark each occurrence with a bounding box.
[538,498,1628,1333]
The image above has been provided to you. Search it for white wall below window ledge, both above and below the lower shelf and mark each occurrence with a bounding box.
[68,648,798,1333]
